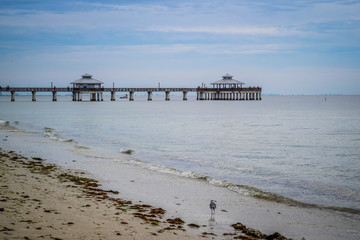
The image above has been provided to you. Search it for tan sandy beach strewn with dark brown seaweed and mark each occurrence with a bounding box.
[0,148,287,240]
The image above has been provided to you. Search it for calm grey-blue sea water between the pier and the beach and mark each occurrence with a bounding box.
[0,96,360,239]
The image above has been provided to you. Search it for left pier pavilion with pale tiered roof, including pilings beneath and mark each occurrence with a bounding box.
[70,73,104,101]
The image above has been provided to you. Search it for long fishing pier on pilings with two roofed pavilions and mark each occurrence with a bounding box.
[0,74,261,101]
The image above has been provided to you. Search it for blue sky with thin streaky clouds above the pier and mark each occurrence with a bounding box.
[0,0,360,95]
